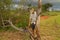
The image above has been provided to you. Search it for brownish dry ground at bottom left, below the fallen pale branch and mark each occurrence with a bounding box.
[0,31,29,40]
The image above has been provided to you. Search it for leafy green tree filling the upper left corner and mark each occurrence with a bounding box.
[0,0,12,26]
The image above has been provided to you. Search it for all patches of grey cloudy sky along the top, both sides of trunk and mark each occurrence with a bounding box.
[14,0,60,9]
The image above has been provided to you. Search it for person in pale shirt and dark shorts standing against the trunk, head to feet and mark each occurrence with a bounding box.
[29,8,37,40]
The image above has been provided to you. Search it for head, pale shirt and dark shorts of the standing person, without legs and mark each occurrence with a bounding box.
[30,8,37,32]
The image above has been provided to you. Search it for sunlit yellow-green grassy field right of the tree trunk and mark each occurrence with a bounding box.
[40,12,60,40]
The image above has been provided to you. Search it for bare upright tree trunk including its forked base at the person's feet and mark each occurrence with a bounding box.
[28,0,42,40]
